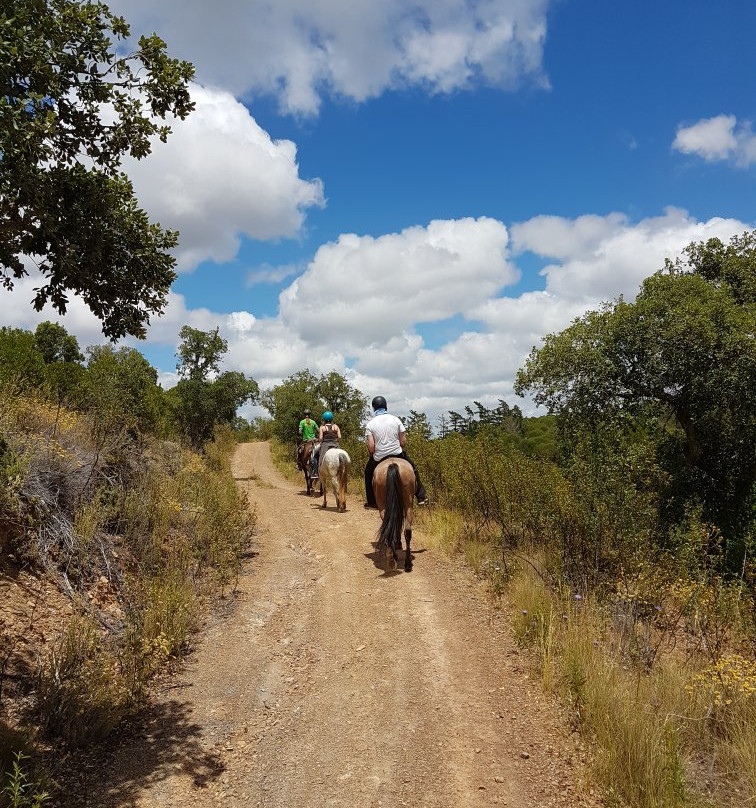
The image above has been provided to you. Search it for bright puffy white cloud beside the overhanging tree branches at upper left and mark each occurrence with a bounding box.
[125,85,324,271]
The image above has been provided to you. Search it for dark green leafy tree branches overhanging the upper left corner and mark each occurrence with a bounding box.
[0,0,194,339]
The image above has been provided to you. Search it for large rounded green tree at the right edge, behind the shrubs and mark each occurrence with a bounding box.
[516,233,756,565]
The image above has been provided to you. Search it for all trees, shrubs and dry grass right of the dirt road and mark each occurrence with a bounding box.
[410,234,756,808]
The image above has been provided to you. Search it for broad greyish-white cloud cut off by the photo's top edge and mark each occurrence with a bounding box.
[109,0,551,115]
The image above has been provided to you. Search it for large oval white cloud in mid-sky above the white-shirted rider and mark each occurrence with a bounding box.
[280,217,519,351]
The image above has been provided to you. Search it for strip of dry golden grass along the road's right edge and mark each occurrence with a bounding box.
[422,498,756,808]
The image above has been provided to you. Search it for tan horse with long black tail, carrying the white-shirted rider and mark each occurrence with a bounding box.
[373,457,415,572]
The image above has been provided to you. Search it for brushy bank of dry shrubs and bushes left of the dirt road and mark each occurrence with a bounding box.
[0,323,257,806]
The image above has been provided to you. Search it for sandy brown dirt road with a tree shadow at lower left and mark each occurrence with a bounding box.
[88,443,596,808]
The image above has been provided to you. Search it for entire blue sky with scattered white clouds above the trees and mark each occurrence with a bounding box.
[5,0,756,417]
